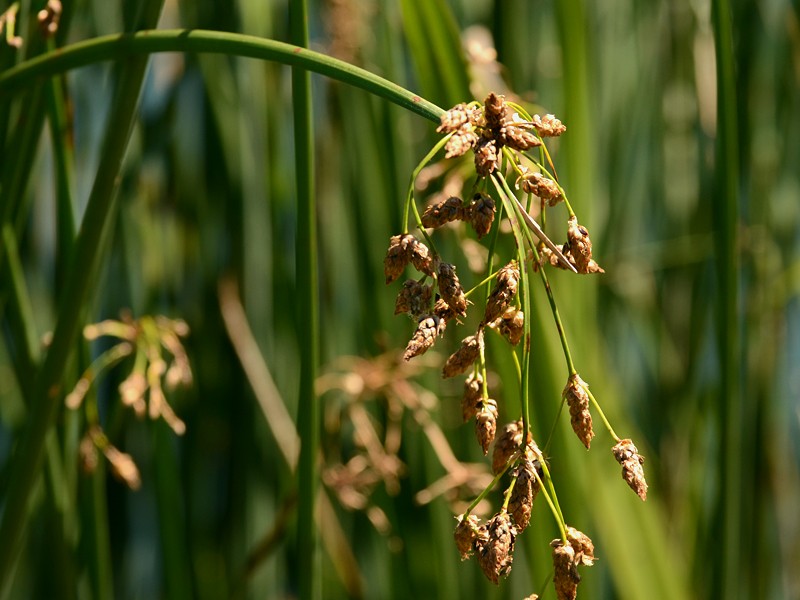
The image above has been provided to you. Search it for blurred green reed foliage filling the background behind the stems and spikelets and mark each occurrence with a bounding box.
[0,0,800,599]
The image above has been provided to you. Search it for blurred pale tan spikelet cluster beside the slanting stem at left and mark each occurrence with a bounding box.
[65,314,193,489]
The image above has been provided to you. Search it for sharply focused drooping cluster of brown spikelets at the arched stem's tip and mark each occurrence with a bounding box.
[384,93,647,600]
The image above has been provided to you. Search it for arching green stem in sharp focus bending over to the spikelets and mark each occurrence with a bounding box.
[0,29,444,123]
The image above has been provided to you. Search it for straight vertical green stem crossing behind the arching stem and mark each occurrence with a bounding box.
[289,0,321,600]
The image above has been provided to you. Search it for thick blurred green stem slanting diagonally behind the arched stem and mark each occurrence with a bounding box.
[0,0,161,594]
